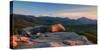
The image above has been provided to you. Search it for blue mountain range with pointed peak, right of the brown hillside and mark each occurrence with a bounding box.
[38,16,97,25]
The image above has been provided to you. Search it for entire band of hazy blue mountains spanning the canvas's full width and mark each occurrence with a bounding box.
[11,14,97,25]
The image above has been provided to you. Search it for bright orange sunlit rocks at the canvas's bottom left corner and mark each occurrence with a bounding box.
[10,35,33,48]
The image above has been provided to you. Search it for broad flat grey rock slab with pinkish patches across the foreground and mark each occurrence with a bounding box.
[15,32,92,49]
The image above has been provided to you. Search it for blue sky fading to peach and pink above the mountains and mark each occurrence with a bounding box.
[11,1,97,19]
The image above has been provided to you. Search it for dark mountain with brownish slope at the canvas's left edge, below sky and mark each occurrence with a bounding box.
[10,14,40,28]
